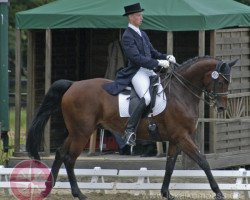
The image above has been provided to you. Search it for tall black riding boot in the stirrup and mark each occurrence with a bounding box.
[123,98,146,146]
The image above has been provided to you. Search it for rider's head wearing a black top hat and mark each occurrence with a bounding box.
[123,3,144,27]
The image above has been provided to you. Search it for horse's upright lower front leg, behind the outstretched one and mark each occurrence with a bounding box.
[161,143,179,200]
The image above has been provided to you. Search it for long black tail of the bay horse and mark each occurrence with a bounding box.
[26,80,73,160]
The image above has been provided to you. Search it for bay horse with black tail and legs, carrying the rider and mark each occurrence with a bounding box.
[26,56,237,200]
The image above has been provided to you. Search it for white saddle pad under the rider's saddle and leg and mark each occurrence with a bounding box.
[118,84,167,117]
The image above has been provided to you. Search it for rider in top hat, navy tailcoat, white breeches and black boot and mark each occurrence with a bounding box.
[104,3,175,146]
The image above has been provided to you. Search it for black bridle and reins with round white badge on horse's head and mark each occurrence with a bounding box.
[162,61,230,106]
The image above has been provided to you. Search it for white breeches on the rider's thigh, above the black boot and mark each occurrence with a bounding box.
[131,67,156,106]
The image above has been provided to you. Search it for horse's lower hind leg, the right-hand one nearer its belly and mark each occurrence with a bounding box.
[62,136,87,200]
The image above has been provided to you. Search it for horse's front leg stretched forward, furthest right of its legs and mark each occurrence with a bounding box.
[180,138,224,200]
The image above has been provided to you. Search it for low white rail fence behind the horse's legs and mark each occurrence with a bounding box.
[0,167,250,199]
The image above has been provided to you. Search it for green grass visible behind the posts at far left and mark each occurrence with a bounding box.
[0,108,26,165]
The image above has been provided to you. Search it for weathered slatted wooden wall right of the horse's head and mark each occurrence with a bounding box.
[210,28,250,167]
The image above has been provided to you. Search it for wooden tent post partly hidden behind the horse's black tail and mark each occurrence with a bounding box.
[44,29,52,156]
